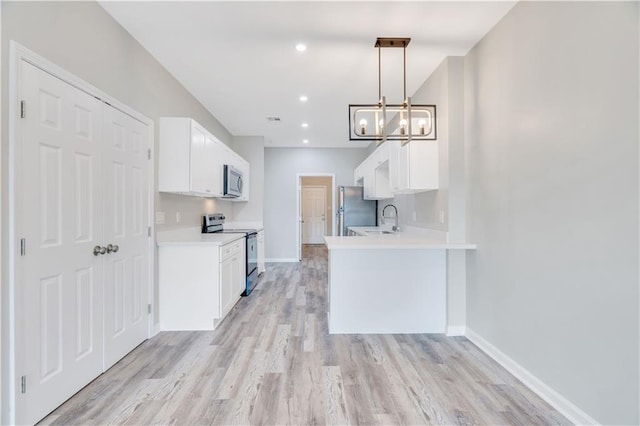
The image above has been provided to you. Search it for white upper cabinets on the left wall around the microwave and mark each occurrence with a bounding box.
[158,117,249,201]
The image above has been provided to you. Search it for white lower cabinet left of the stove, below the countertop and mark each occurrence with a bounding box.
[158,238,245,330]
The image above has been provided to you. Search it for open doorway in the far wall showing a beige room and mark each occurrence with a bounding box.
[296,173,336,260]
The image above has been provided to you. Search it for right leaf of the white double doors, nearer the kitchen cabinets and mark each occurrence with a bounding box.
[102,105,149,370]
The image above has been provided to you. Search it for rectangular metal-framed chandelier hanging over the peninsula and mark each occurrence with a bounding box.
[349,37,436,145]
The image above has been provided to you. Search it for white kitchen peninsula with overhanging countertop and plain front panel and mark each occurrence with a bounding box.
[325,227,476,334]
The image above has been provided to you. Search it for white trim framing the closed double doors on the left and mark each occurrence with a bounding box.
[5,40,155,424]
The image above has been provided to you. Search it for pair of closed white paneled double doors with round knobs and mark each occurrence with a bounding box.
[16,61,149,423]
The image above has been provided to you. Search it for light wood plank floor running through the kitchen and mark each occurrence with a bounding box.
[42,246,569,425]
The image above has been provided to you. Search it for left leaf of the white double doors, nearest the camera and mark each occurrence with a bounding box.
[16,62,103,424]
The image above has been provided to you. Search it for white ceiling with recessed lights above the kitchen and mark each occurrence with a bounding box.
[100,1,515,147]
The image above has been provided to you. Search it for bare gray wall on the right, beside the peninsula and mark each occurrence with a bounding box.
[465,2,640,424]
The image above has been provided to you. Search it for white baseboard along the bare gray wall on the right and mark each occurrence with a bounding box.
[465,328,599,425]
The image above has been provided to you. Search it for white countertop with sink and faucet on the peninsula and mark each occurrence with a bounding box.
[324,227,476,250]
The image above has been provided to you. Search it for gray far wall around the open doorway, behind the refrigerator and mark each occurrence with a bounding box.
[264,148,367,259]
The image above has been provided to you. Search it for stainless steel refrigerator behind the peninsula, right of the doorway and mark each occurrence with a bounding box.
[336,186,378,236]
